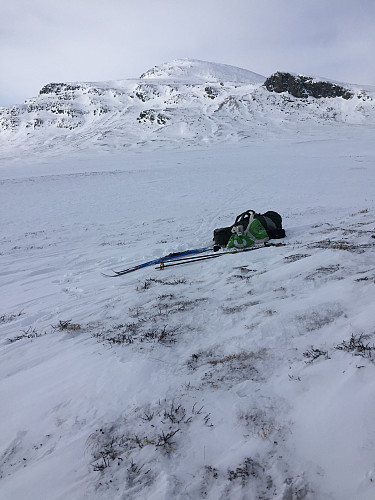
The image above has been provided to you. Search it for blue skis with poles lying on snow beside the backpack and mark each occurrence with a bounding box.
[104,242,284,278]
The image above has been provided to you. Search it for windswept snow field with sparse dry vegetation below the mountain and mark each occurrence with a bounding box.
[0,59,375,500]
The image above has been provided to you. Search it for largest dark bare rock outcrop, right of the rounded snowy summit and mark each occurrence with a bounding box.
[264,72,353,99]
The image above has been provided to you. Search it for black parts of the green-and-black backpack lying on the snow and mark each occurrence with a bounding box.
[214,210,285,247]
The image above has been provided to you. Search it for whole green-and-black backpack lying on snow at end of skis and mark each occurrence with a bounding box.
[214,210,285,248]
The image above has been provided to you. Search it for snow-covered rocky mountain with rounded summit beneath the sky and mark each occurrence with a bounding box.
[0,60,375,156]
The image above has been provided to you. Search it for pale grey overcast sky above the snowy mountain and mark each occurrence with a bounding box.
[0,0,375,106]
